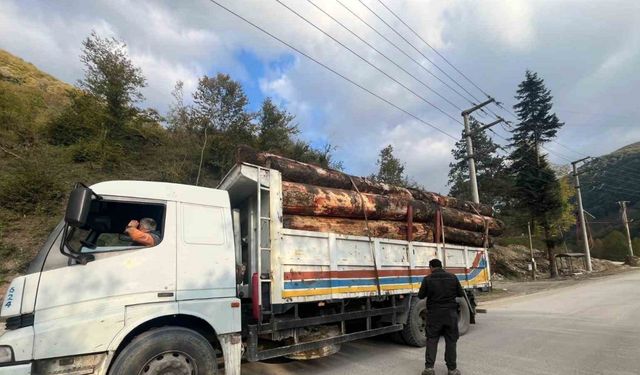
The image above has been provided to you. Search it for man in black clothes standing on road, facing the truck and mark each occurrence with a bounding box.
[418,259,464,375]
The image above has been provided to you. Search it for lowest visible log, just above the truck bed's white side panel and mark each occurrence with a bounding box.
[284,215,491,247]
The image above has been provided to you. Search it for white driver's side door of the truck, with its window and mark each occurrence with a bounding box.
[34,197,176,359]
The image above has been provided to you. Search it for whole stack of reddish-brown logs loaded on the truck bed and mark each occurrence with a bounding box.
[236,146,504,246]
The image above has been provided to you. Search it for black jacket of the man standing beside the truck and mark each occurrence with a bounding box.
[418,268,464,310]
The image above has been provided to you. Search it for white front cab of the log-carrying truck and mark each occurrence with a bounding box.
[0,181,241,374]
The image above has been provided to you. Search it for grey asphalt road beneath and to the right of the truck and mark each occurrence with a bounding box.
[242,271,640,375]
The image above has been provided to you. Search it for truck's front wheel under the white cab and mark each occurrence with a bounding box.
[109,327,218,375]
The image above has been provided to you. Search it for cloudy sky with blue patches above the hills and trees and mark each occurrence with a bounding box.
[0,0,640,193]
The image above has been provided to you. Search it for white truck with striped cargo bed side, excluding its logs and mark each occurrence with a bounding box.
[0,164,490,375]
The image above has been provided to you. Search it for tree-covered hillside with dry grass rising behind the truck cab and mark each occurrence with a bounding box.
[0,46,339,292]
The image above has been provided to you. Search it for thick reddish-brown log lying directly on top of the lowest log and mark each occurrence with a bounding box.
[282,181,504,235]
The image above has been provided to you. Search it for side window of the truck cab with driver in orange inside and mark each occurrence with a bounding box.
[69,200,165,253]
